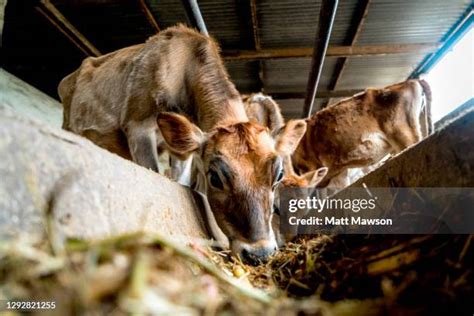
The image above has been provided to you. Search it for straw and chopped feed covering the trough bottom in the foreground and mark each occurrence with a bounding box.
[0,234,474,315]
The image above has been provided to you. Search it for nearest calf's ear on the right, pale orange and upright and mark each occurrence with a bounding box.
[275,120,306,155]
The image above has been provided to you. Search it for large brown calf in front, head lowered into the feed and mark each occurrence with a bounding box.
[59,26,306,262]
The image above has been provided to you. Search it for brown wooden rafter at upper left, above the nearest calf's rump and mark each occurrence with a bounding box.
[37,0,102,56]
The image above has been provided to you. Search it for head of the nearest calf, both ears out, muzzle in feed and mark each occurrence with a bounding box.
[158,113,306,263]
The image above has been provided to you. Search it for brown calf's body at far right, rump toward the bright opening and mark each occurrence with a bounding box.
[292,80,431,186]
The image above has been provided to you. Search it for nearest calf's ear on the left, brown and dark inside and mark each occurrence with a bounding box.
[157,112,206,159]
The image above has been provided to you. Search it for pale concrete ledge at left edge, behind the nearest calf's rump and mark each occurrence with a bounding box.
[0,69,63,128]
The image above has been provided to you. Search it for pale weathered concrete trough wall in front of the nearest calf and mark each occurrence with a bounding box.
[0,106,208,243]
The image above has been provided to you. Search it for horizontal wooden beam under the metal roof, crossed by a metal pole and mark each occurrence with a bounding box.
[222,43,440,60]
